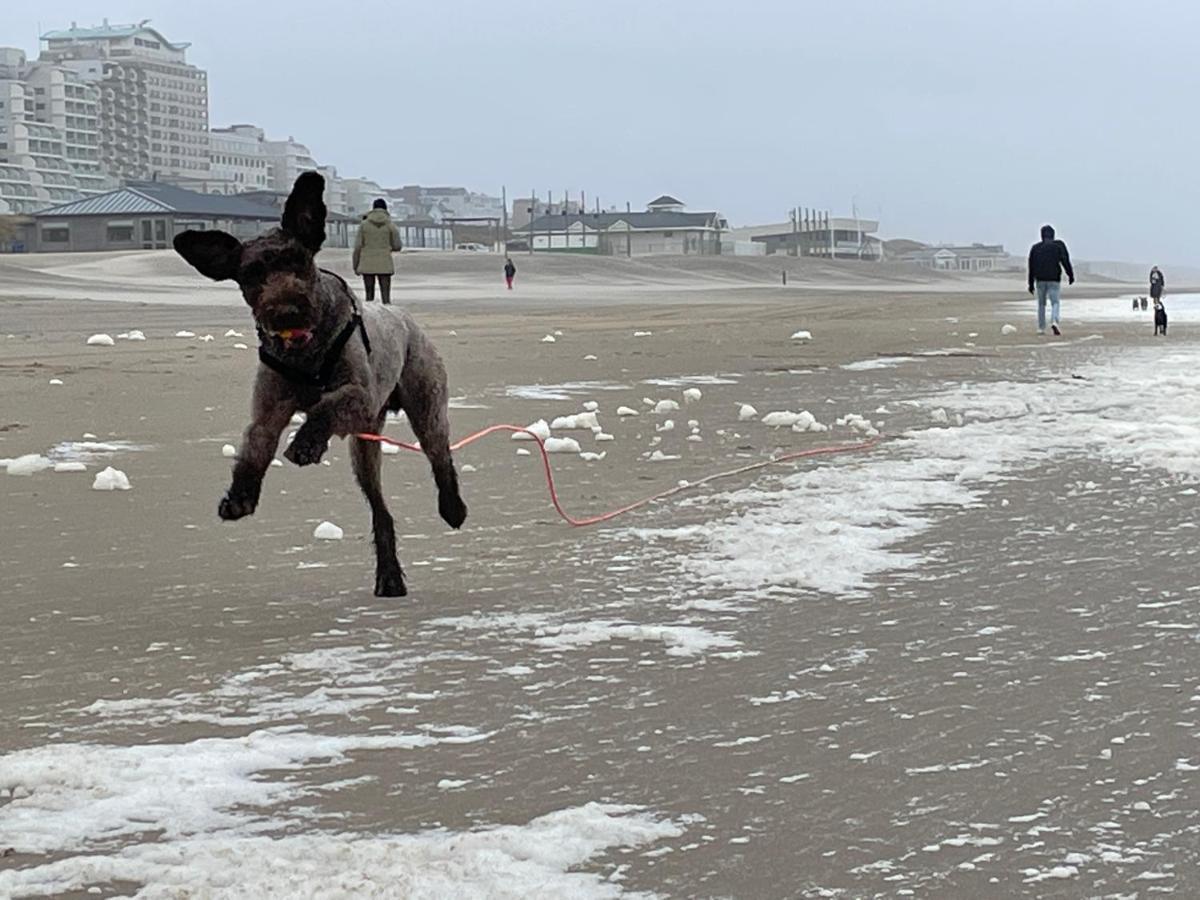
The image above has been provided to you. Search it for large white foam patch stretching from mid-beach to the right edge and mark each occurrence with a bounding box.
[632,346,1200,596]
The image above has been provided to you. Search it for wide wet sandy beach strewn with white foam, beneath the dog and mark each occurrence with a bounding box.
[0,252,1200,898]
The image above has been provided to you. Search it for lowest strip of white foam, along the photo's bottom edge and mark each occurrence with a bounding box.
[0,803,684,900]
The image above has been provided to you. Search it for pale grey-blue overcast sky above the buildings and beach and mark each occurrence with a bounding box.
[9,0,1200,264]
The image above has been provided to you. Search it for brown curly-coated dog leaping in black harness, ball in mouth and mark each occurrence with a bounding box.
[174,172,467,596]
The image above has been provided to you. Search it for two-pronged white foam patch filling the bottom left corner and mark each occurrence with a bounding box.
[0,727,684,900]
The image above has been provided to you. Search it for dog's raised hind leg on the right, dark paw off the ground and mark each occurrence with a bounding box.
[400,358,467,528]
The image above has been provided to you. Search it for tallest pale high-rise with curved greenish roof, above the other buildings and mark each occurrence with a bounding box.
[41,19,209,179]
